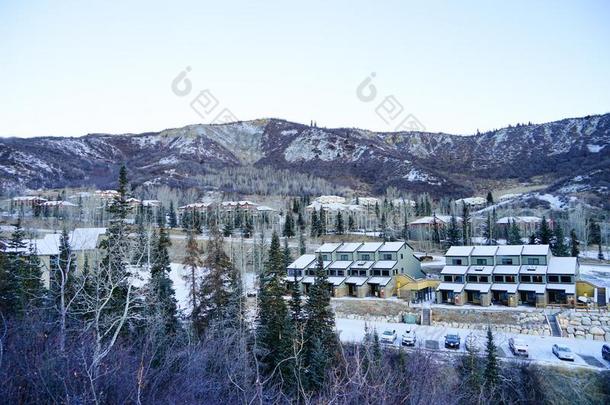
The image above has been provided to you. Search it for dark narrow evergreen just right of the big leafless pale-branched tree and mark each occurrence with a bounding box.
[146,228,179,336]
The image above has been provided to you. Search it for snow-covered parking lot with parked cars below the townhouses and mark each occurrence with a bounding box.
[336,318,610,369]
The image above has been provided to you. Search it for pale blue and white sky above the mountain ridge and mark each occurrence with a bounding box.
[0,0,610,137]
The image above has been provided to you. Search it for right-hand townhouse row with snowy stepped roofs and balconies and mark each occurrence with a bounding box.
[436,245,579,307]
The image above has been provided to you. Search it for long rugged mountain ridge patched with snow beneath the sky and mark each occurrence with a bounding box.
[0,114,610,207]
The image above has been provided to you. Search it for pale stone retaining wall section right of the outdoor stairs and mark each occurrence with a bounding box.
[557,310,610,342]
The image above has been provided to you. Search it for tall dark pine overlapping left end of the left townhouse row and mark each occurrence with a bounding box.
[303,256,338,390]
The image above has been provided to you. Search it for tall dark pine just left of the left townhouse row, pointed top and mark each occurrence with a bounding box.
[256,232,294,381]
